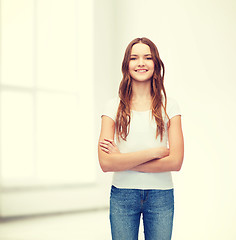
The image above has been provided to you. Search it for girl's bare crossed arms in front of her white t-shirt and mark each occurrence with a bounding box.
[98,115,184,172]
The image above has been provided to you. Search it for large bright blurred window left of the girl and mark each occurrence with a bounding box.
[0,0,97,187]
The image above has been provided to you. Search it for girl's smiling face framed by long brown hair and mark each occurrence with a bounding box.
[129,43,154,82]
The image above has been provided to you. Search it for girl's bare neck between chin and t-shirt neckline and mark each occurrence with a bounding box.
[132,80,151,100]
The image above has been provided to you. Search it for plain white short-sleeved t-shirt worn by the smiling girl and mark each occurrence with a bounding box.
[102,97,181,189]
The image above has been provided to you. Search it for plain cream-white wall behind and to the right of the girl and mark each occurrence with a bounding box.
[107,0,236,240]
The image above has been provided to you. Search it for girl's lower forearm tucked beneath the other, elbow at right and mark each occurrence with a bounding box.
[130,155,183,173]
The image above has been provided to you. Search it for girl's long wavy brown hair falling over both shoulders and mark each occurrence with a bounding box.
[116,37,169,141]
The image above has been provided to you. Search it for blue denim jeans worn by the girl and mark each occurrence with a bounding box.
[110,186,174,240]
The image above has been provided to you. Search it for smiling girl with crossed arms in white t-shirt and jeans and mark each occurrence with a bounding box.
[98,38,184,240]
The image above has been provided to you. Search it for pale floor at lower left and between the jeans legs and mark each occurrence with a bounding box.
[0,210,144,240]
